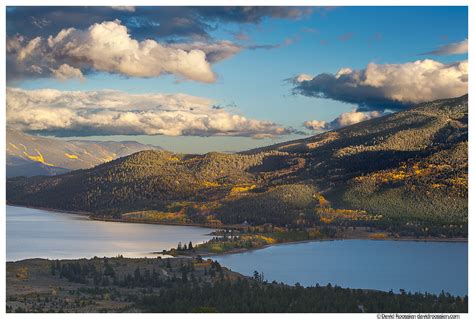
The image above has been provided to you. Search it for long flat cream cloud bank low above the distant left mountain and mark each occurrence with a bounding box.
[7,88,293,138]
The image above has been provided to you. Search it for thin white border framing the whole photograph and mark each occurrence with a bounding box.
[0,0,474,318]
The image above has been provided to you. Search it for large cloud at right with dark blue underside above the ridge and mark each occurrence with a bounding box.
[290,59,468,111]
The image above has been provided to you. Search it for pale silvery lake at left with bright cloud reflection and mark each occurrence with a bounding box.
[6,206,213,261]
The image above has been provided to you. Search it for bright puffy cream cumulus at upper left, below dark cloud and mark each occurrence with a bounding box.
[7,20,241,83]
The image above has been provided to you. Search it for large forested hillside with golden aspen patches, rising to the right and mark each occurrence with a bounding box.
[7,95,468,236]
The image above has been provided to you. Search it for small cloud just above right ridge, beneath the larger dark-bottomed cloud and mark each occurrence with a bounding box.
[303,110,383,131]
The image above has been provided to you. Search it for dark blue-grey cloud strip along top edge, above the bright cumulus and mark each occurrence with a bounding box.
[7,6,311,39]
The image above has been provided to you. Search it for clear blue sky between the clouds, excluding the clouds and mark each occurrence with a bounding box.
[7,7,468,153]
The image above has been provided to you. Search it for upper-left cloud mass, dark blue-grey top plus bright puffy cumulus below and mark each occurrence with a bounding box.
[6,6,311,83]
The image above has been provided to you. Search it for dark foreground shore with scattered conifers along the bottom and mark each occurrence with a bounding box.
[6,256,468,313]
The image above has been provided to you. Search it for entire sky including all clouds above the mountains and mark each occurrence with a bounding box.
[6,7,468,153]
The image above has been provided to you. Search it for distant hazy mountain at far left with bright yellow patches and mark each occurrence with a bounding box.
[6,129,160,177]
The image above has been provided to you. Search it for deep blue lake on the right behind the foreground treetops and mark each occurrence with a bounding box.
[215,240,468,296]
